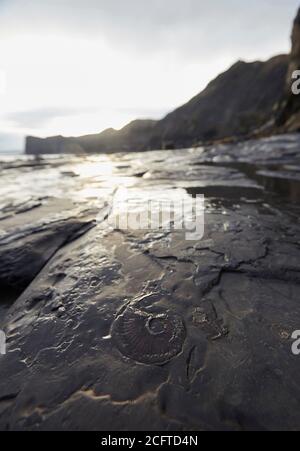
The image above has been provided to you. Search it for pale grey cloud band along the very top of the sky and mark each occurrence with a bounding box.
[0,0,298,59]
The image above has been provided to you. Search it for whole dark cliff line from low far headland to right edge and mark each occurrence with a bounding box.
[26,9,300,154]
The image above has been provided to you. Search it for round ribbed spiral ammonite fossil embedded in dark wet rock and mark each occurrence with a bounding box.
[112,307,185,365]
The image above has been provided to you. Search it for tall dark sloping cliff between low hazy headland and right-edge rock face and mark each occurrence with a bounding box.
[151,55,288,148]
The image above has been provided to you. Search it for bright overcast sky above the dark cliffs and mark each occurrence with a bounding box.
[0,0,300,152]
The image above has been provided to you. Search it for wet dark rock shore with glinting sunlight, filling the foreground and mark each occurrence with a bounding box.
[0,135,300,431]
